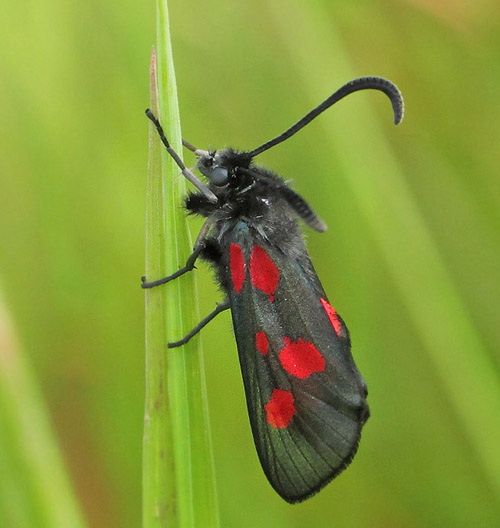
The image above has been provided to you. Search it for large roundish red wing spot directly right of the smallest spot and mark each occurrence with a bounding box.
[279,337,326,379]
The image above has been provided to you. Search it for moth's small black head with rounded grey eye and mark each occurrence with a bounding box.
[196,149,252,187]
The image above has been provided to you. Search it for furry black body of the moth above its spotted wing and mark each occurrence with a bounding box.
[185,149,321,293]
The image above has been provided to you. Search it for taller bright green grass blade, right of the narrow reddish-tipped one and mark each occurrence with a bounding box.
[147,0,219,528]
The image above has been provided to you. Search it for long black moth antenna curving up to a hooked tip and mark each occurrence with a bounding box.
[248,77,404,157]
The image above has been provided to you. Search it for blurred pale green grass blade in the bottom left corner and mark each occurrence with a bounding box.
[0,292,85,528]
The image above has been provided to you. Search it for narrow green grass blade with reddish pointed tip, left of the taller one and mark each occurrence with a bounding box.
[143,51,176,528]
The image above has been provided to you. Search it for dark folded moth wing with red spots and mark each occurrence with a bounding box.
[225,221,369,503]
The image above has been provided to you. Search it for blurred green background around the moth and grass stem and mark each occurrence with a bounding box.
[0,0,500,528]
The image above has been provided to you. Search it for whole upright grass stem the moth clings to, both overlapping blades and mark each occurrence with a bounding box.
[143,1,219,528]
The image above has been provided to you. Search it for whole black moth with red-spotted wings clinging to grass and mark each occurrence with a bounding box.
[142,77,404,503]
